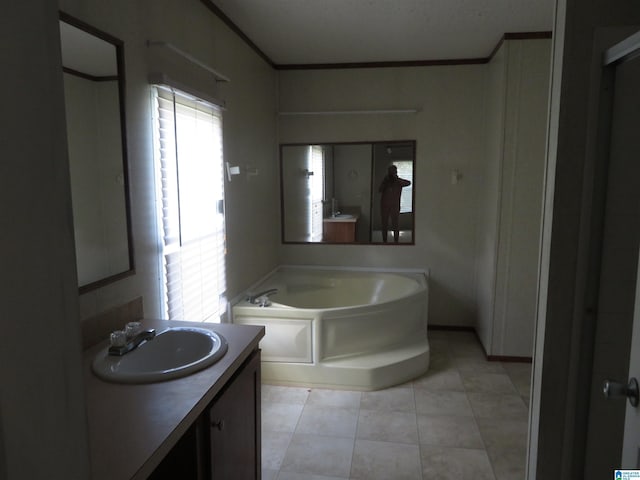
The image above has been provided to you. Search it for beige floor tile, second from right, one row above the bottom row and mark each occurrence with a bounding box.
[418,415,484,448]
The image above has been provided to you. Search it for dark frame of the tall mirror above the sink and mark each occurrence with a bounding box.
[59,11,136,294]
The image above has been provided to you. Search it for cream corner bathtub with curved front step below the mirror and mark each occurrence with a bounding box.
[232,267,429,390]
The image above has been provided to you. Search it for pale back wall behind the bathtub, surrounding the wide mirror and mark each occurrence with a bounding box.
[278,65,487,325]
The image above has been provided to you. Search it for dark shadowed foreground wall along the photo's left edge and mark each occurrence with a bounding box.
[0,0,89,480]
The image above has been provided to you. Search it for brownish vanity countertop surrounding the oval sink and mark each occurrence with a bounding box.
[84,320,264,480]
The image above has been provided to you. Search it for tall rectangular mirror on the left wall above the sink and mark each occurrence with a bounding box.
[60,13,134,293]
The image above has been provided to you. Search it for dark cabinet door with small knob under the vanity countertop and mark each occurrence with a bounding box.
[209,351,262,480]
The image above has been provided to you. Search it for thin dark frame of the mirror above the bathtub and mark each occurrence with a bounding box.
[278,139,417,246]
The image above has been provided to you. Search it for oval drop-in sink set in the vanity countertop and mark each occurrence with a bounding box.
[92,327,228,383]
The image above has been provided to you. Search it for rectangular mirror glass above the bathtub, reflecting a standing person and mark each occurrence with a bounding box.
[280,140,416,245]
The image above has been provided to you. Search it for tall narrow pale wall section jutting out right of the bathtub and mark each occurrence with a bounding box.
[477,39,551,357]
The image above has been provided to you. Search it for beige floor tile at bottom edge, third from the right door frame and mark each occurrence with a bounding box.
[350,440,422,480]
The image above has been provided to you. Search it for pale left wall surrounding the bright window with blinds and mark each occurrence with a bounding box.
[59,0,279,324]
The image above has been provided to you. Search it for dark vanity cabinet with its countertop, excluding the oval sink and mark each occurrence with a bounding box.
[84,319,264,480]
